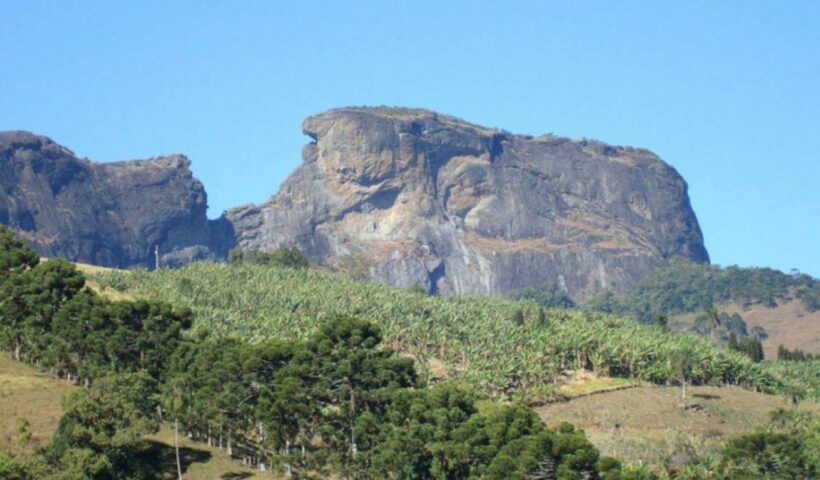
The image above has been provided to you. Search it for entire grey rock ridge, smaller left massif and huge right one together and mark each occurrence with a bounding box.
[0,108,708,296]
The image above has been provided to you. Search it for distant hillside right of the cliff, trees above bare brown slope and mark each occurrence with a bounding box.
[580,259,820,359]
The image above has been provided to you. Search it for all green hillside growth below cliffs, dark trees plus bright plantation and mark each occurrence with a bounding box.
[0,230,820,480]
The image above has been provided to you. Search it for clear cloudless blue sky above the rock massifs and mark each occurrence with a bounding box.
[0,0,820,276]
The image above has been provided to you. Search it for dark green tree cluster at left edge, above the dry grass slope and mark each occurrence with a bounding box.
[0,249,191,382]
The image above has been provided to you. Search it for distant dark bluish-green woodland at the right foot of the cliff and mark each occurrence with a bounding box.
[585,259,820,323]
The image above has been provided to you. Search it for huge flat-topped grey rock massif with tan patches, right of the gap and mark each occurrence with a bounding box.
[224,108,709,296]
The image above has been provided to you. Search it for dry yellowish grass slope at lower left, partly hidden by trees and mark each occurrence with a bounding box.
[0,352,270,480]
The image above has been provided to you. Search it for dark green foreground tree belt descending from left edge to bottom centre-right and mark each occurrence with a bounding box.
[0,228,636,480]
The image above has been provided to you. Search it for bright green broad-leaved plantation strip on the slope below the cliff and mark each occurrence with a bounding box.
[88,263,780,399]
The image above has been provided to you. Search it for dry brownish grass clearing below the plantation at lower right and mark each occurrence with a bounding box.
[537,386,820,464]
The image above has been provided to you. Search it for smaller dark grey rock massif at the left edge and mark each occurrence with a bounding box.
[0,132,232,267]
